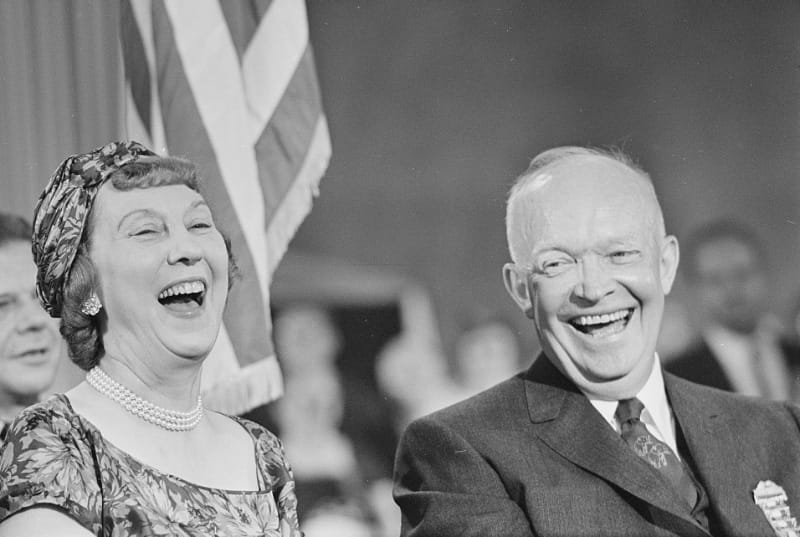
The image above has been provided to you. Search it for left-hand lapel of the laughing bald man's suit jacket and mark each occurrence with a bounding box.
[526,356,708,535]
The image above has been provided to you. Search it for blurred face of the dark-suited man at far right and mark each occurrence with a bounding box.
[693,237,769,334]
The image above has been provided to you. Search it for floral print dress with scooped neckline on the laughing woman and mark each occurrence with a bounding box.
[0,395,301,537]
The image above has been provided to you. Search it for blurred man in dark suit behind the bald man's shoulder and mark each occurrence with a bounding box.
[666,220,800,400]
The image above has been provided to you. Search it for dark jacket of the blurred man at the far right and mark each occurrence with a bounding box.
[664,339,800,391]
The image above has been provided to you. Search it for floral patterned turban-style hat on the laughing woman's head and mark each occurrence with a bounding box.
[33,141,155,317]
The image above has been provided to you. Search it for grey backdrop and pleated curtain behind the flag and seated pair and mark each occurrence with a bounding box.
[0,0,800,360]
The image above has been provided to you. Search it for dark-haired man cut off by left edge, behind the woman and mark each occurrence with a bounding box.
[0,213,61,442]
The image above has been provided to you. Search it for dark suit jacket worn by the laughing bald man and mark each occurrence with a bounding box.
[394,357,800,537]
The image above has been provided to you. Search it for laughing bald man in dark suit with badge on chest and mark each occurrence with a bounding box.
[394,147,800,537]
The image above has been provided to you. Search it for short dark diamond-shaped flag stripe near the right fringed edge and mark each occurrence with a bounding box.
[256,48,322,225]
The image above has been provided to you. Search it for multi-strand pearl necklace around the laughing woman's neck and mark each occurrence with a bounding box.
[86,366,204,431]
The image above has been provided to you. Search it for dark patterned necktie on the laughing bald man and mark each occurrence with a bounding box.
[614,398,697,508]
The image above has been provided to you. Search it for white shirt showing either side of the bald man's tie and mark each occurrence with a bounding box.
[589,354,680,459]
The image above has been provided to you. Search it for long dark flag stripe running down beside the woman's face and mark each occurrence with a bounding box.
[153,2,272,364]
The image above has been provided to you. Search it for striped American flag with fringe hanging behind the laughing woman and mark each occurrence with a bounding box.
[121,0,331,414]
